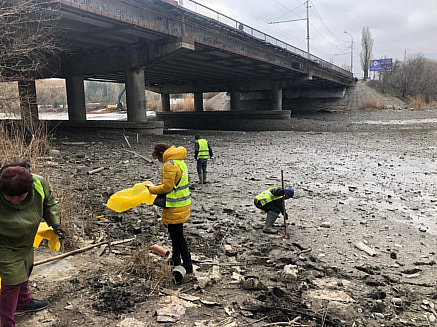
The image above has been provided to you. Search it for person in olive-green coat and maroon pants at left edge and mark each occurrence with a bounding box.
[0,161,65,327]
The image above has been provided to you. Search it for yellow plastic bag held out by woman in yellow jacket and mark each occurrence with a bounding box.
[106,181,156,212]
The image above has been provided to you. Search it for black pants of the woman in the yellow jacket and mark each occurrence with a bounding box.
[168,224,193,273]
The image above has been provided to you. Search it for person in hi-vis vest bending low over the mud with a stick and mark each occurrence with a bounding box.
[254,186,294,234]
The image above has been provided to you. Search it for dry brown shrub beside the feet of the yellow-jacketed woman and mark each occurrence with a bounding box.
[123,246,173,286]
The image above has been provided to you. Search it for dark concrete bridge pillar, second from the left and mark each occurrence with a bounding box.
[65,75,86,120]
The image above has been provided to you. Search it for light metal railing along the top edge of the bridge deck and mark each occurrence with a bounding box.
[179,0,353,78]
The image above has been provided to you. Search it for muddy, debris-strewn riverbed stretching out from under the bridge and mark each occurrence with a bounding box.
[17,110,437,327]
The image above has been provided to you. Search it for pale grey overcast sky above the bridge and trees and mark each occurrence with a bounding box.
[179,0,437,76]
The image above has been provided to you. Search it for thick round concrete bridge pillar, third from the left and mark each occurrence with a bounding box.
[125,68,147,121]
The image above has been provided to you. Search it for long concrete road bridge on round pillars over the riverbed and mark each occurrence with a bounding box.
[19,0,354,130]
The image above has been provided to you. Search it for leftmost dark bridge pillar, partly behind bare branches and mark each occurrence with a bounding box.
[18,81,38,127]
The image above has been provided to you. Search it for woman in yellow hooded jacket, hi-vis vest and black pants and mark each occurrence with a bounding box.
[146,143,193,274]
